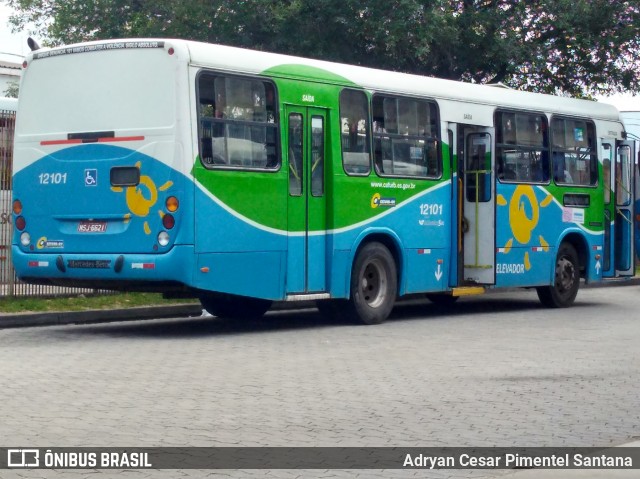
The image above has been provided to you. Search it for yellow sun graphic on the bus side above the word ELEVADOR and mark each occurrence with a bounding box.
[497,185,553,271]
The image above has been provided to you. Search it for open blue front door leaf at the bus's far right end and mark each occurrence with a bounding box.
[612,141,635,276]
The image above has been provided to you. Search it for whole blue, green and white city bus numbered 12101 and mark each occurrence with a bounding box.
[12,39,635,324]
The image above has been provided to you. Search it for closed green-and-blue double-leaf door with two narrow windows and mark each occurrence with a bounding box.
[284,106,329,294]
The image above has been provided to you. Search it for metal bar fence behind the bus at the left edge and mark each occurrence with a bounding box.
[0,109,112,298]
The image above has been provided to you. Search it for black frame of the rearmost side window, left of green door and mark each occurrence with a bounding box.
[195,68,282,173]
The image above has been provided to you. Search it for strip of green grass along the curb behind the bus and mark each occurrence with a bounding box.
[0,293,197,313]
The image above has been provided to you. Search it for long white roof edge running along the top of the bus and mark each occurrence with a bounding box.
[27,39,620,121]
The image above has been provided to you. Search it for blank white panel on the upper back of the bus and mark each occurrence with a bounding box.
[18,49,176,134]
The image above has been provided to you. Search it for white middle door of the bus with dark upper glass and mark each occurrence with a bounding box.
[458,126,496,285]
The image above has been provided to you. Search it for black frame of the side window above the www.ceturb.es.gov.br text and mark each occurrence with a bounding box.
[369,91,444,181]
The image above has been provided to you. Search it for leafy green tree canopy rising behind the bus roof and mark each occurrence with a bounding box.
[5,0,640,96]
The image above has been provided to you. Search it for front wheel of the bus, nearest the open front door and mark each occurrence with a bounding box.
[536,243,580,308]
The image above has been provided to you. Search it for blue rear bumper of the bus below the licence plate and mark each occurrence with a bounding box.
[12,245,194,285]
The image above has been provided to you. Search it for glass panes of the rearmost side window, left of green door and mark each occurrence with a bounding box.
[198,73,279,170]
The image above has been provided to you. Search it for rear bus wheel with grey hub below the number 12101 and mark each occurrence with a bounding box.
[346,243,398,324]
